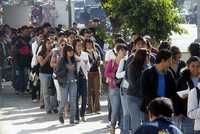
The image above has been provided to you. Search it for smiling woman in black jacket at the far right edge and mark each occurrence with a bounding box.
[177,56,200,134]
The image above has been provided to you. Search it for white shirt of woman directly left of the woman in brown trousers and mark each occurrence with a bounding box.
[75,52,90,79]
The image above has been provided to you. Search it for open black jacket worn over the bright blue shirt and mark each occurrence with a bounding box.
[141,66,179,113]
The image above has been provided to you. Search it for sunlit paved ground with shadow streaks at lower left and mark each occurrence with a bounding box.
[0,83,119,134]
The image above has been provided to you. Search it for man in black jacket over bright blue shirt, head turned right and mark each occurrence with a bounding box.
[141,50,178,111]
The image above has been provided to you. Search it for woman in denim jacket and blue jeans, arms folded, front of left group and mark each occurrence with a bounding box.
[55,45,77,124]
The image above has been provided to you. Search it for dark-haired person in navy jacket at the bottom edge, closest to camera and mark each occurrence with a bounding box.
[135,97,183,134]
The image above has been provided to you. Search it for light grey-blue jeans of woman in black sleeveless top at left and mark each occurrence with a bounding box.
[39,73,57,112]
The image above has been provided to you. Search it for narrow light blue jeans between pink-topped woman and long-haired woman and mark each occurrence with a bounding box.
[120,88,131,134]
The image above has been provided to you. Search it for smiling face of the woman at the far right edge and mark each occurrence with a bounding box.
[188,61,200,77]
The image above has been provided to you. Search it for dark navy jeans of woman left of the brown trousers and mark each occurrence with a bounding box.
[76,78,87,120]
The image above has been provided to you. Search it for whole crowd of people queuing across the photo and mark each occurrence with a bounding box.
[0,19,200,134]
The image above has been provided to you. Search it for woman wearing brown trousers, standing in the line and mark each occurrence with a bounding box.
[84,39,100,114]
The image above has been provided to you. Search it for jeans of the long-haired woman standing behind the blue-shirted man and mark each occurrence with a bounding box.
[127,95,144,133]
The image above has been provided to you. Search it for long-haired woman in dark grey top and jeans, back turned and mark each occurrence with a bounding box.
[127,48,150,132]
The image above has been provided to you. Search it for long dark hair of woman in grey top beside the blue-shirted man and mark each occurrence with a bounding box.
[128,48,149,71]
